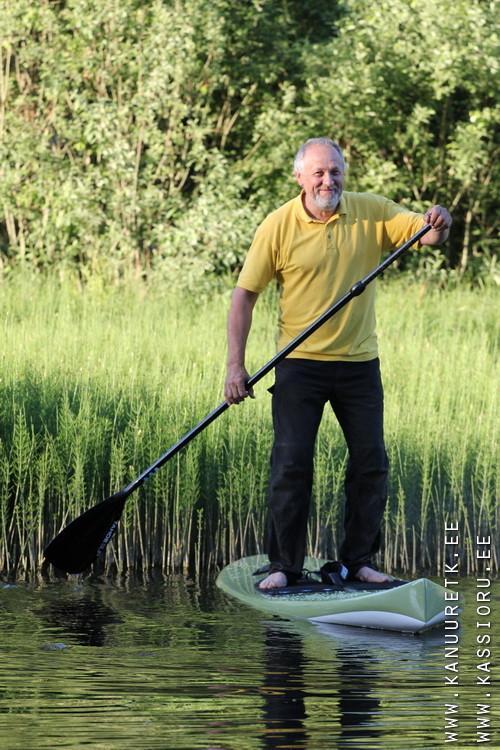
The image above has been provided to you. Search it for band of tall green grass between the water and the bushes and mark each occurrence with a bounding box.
[0,277,498,575]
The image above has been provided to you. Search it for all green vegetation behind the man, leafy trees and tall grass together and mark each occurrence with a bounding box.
[0,0,500,573]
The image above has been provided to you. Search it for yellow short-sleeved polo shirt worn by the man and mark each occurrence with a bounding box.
[237,192,425,362]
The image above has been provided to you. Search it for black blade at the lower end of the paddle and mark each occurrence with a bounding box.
[44,491,129,573]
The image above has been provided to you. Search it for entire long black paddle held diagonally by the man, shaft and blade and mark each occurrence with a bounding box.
[44,224,431,573]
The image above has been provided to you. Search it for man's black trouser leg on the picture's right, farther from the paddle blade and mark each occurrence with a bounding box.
[331,359,389,567]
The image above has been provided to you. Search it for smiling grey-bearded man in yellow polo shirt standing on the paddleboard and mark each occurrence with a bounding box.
[225,138,451,589]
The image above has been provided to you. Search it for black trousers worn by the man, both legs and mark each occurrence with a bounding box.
[266,359,388,576]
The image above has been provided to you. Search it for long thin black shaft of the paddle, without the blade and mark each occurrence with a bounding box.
[122,224,431,496]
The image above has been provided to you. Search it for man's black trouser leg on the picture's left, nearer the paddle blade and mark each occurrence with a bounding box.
[266,359,327,577]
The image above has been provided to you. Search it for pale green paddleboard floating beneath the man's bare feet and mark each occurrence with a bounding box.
[217,555,445,633]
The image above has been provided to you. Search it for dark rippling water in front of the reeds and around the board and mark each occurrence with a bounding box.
[0,579,500,750]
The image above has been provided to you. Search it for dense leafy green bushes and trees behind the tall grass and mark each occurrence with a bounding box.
[0,0,500,284]
